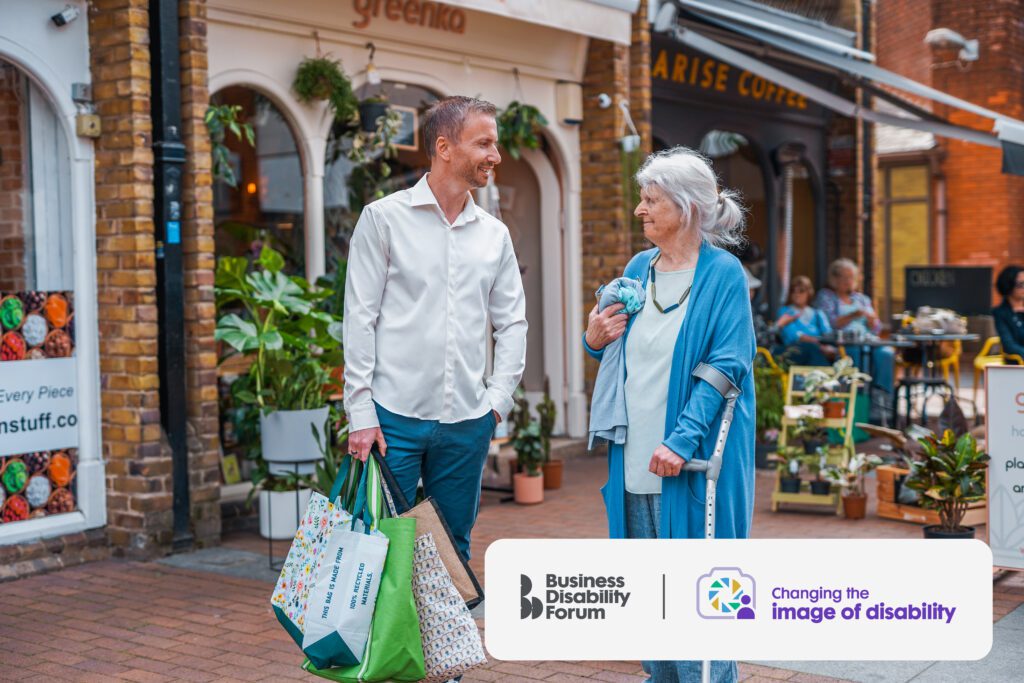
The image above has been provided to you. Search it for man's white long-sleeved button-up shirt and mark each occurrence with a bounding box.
[344,175,526,431]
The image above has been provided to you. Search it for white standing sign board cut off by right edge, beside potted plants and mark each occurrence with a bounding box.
[985,366,1024,569]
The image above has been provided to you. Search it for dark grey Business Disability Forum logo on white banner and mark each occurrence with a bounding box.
[519,573,632,621]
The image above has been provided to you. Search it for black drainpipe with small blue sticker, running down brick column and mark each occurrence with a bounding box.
[150,0,194,552]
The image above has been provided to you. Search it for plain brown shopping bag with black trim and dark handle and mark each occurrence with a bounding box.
[372,449,483,609]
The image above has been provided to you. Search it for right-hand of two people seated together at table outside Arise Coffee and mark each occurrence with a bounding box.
[814,258,895,394]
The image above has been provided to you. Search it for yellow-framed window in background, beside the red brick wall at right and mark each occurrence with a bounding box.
[873,164,931,319]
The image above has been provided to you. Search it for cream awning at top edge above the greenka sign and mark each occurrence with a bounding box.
[441,0,640,45]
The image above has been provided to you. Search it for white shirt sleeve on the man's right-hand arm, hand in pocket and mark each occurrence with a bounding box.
[486,233,527,420]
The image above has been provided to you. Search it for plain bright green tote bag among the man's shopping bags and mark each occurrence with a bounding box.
[302,458,426,683]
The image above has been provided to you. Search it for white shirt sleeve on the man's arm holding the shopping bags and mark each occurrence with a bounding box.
[342,207,388,431]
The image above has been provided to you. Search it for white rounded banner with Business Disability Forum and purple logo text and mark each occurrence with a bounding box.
[484,539,992,660]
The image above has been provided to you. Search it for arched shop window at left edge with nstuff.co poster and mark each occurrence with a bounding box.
[0,59,78,529]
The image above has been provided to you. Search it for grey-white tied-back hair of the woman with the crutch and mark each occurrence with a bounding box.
[637,146,745,247]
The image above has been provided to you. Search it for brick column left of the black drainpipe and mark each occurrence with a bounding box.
[89,0,172,557]
